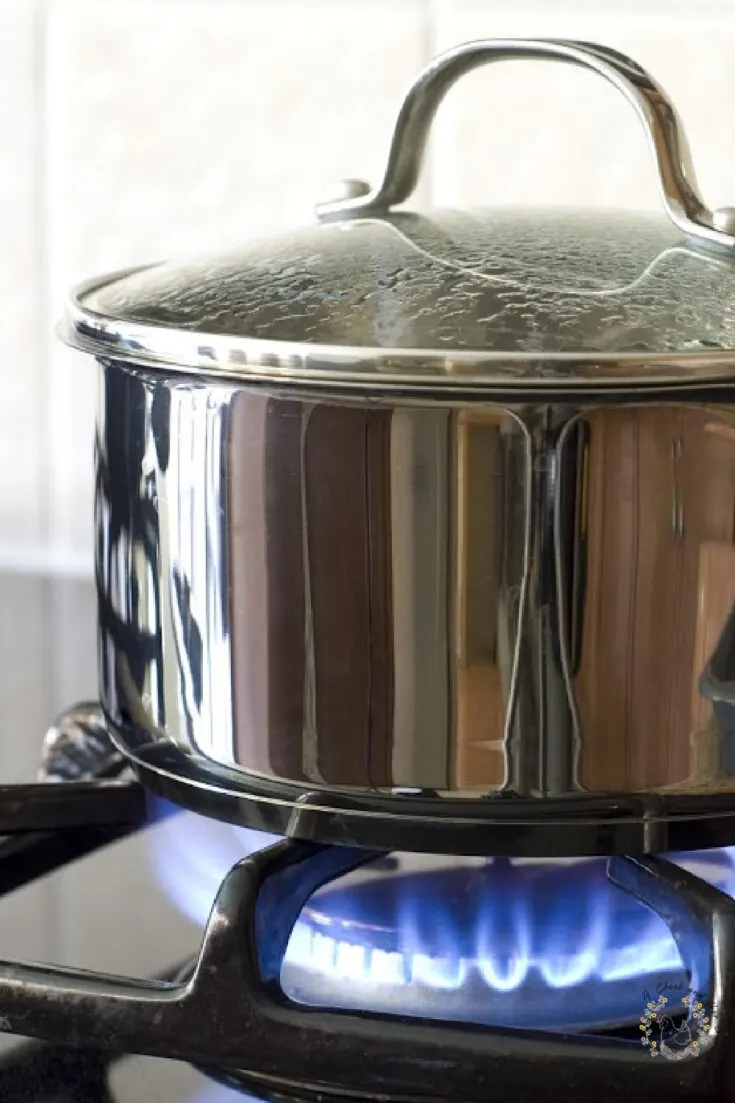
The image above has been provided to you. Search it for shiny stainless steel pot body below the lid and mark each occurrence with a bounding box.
[96,362,735,854]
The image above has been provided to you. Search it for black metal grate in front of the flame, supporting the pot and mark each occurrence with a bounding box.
[0,763,735,1103]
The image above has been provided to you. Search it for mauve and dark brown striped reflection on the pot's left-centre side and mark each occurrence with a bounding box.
[228,394,393,785]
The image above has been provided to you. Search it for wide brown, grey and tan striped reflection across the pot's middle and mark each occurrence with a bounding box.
[222,394,529,790]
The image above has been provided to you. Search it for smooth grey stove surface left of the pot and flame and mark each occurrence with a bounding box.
[0,574,247,1103]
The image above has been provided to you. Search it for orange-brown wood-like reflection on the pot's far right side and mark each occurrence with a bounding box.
[575,407,735,790]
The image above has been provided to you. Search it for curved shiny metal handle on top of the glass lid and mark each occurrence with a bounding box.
[317,39,735,248]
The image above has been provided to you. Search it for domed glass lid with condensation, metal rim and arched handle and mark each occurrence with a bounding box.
[63,40,735,392]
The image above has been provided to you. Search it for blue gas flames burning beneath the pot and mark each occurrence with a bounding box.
[144,813,735,1029]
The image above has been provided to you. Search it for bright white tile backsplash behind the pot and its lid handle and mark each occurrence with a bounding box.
[0,0,735,574]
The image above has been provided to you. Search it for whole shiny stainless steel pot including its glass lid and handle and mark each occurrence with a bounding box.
[60,41,735,855]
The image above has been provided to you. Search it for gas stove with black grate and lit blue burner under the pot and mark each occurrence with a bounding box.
[0,576,735,1103]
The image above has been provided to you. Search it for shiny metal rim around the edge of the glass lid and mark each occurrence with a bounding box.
[57,265,735,397]
